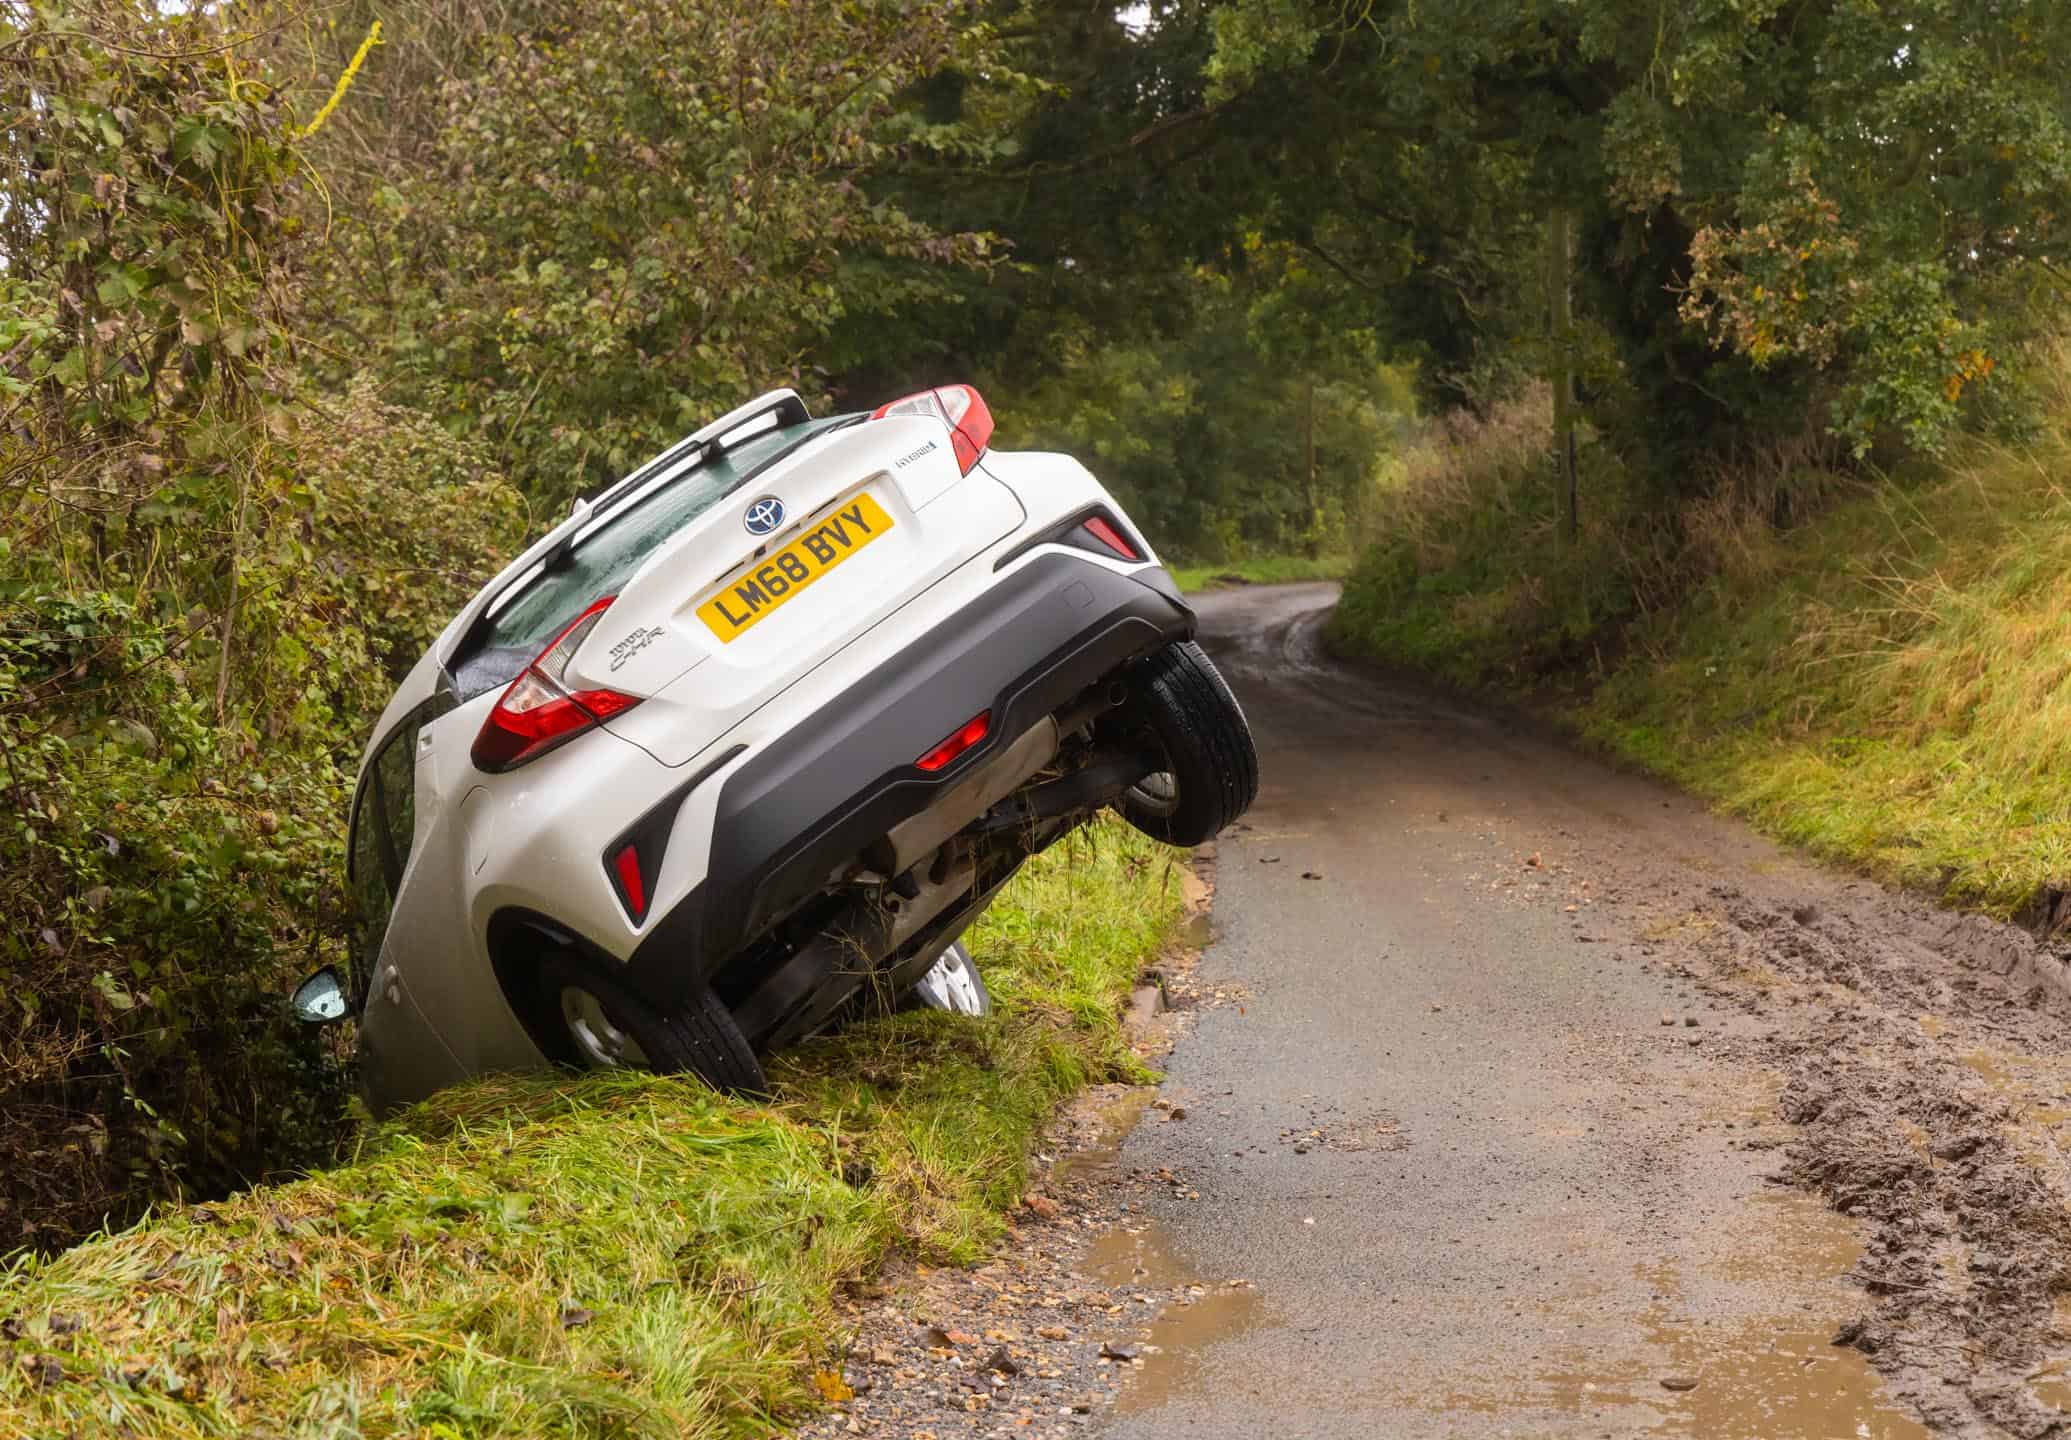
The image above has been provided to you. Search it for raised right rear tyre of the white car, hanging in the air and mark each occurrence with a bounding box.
[1114,640,1259,845]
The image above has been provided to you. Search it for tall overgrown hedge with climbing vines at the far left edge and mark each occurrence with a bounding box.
[0,0,516,1249]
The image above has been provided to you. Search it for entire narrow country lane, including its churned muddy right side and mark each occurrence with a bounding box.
[1096,584,2071,1440]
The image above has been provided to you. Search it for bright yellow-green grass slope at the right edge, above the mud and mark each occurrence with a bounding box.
[1570,445,2071,916]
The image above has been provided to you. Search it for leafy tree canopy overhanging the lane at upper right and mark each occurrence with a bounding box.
[1085,0,2071,470]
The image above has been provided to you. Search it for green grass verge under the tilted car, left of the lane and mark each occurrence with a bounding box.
[0,823,1183,1440]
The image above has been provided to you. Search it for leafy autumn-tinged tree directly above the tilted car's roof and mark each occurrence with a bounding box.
[311,0,1006,506]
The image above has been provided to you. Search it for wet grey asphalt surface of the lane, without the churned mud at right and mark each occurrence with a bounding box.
[1096,584,1924,1440]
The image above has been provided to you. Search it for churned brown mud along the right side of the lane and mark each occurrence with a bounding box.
[1682,881,2071,1440]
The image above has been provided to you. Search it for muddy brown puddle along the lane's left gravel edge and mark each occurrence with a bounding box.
[1089,1225,1263,1415]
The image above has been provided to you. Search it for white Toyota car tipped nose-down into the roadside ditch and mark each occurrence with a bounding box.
[296,385,1257,1104]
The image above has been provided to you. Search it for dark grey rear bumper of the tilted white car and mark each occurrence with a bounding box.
[623,553,1195,1005]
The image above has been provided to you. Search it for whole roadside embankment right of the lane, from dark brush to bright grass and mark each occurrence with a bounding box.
[1332,360,2071,926]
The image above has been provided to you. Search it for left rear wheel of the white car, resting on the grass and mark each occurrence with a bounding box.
[541,955,768,1094]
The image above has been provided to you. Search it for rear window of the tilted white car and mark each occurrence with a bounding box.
[451,414,855,700]
